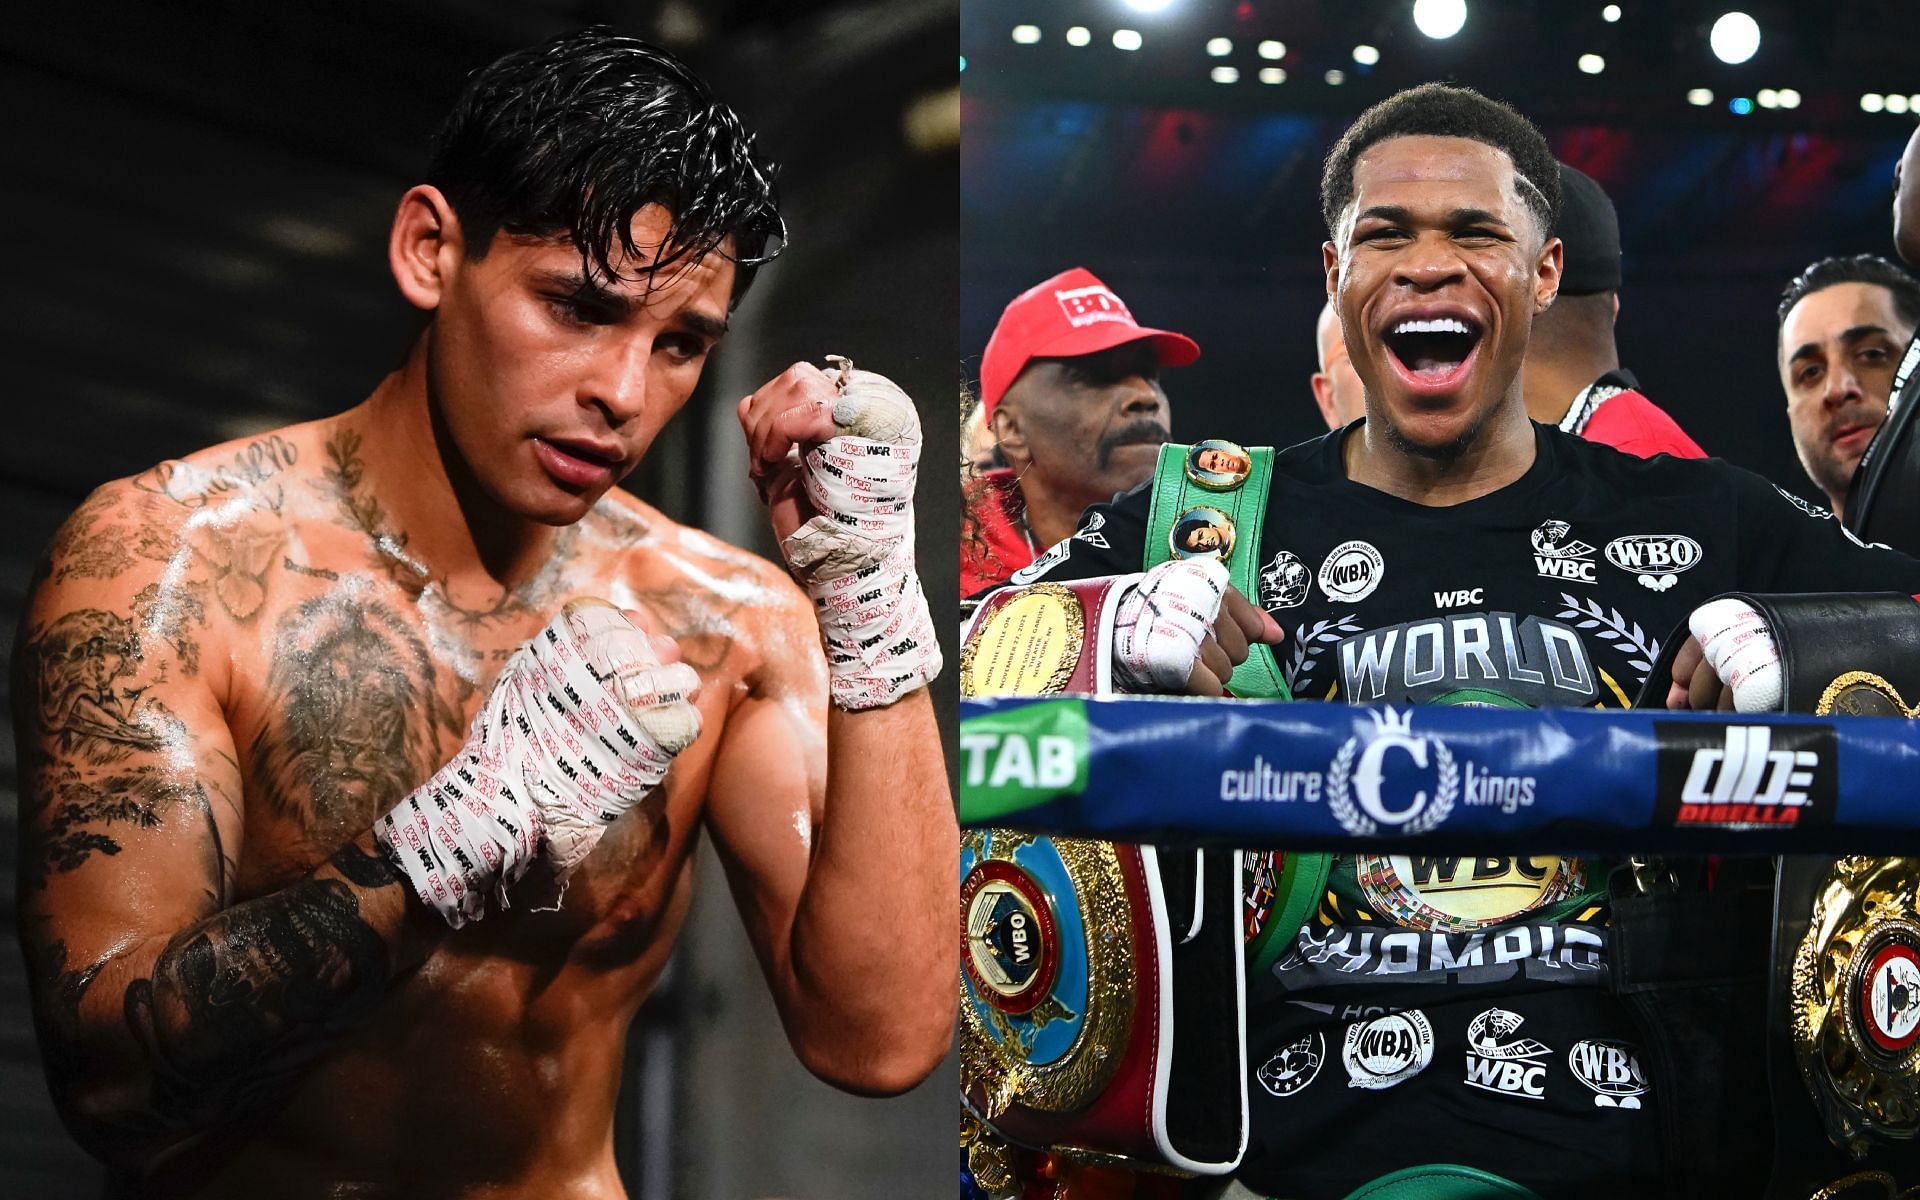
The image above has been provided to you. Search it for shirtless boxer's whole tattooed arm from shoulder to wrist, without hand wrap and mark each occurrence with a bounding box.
[13,484,445,1169]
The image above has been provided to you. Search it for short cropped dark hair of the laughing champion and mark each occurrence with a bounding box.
[1321,83,1561,236]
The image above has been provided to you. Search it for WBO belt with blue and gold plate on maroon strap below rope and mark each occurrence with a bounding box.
[960,829,1246,1175]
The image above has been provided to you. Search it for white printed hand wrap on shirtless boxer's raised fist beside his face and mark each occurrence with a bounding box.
[780,357,941,710]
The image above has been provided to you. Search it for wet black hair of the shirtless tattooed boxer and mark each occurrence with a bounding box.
[426,29,787,303]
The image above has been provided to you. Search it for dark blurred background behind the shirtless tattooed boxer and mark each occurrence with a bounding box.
[0,0,960,1200]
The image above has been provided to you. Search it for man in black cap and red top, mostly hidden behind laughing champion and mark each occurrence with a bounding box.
[1523,163,1705,459]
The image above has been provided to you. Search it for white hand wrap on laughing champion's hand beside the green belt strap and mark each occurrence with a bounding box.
[1114,559,1233,693]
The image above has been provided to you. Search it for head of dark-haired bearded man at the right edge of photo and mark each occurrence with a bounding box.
[1780,253,1920,518]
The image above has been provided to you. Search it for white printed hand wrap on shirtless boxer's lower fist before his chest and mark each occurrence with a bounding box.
[374,599,701,929]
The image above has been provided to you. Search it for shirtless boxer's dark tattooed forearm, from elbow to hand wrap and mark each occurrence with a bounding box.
[61,833,447,1169]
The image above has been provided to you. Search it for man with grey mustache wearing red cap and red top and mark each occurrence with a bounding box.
[960,267,1200,595]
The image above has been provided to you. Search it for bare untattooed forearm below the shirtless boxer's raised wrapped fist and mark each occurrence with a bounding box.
[781,687,960,1094]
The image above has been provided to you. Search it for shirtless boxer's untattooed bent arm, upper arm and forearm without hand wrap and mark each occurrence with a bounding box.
[707,570,960,1094]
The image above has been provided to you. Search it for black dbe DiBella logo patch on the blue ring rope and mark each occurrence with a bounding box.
[1653,722,1837,829]
